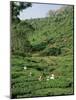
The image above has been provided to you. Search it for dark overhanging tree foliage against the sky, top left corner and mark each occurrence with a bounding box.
[10,1,31,20]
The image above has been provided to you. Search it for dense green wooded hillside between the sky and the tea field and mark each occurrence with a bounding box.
[11,6,73,56]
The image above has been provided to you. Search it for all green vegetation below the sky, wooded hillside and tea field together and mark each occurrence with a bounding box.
[11,6,74,98]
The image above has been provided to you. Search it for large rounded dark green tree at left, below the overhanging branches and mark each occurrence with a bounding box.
[11,21,34,54]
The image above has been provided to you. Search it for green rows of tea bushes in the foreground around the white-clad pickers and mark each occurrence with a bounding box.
[11,56,73,98]
